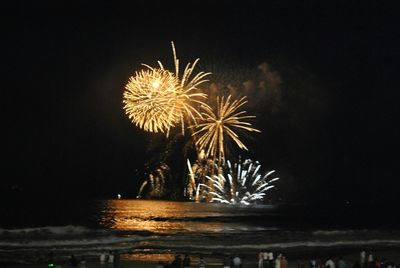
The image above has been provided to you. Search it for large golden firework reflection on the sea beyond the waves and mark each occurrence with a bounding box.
[98,200,274,234]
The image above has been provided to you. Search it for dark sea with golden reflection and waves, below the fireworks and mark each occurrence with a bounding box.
[0,199,400,263]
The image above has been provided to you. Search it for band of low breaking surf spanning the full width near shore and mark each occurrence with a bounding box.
[0,225,400,250]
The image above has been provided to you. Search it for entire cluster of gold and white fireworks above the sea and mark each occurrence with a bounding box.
[123,42,278,205]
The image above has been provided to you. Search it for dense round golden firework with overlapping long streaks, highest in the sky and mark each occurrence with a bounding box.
[123,42,210,136]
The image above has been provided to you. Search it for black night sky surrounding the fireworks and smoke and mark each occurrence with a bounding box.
[1,1,400,202]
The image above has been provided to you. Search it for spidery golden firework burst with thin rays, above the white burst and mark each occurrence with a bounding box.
[193,95,260,161]
